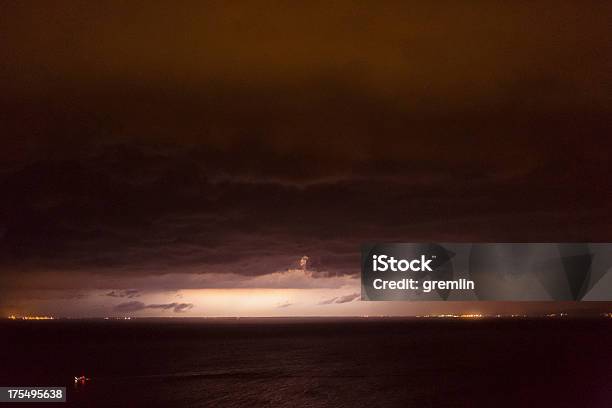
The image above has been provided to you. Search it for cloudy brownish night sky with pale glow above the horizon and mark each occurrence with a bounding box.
[0,1,612,316]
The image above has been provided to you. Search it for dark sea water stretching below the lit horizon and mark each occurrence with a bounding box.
[0,319,612,408]
